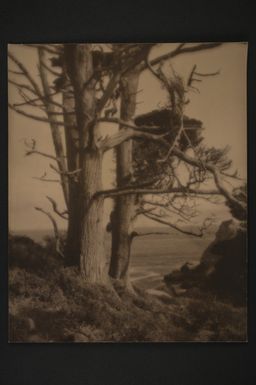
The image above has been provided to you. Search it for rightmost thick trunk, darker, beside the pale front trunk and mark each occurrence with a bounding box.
[109,70,139,285]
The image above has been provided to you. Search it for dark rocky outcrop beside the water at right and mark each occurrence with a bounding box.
[164,219,247,305]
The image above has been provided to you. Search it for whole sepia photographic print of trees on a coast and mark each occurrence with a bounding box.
[8,42,248,343]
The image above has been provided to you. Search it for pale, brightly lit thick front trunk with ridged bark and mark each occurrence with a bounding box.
[65,44,107,283]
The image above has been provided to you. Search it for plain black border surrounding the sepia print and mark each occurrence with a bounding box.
[0,0,256,385]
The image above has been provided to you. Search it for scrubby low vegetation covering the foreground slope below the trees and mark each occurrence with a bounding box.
[9,232,246,342]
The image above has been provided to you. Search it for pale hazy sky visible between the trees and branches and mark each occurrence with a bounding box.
[9,43,247,231]
